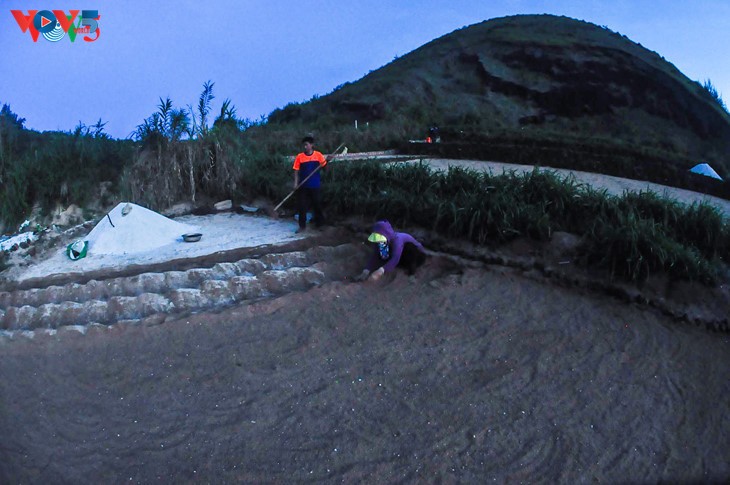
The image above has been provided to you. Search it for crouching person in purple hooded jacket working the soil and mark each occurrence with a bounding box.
[356,221,426,281]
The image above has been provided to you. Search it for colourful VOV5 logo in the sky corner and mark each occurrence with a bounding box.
[10,10,101,42]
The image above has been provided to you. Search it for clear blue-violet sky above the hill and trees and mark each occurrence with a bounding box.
[0,0,730,138]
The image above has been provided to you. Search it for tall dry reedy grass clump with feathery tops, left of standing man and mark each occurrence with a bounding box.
[122,81,270,209]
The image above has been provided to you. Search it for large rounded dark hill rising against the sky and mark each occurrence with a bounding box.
[269,15,730,178]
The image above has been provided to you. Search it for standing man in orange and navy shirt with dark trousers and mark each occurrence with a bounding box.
[294,135,327,232]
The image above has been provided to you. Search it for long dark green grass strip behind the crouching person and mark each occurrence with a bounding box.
[324,162,730,284]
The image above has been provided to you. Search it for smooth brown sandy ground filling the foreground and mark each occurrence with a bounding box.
[0,253,730,483]
